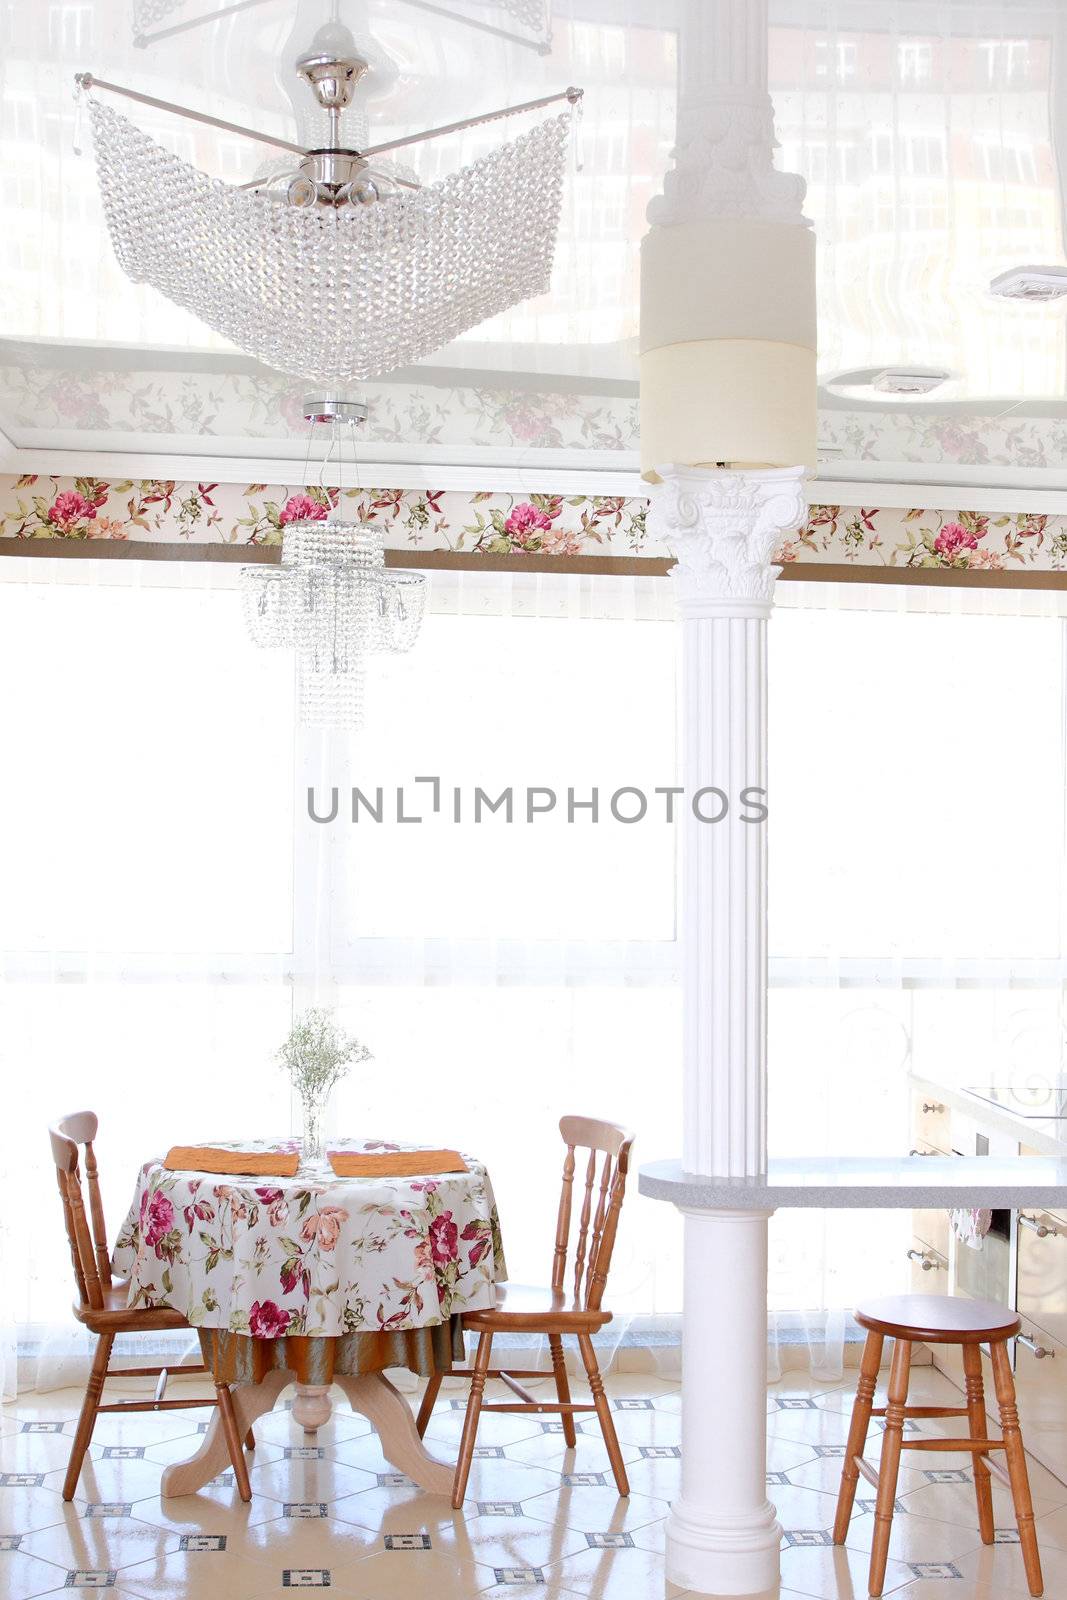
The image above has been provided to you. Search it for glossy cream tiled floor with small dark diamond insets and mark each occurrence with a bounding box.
[0,1368,1067,1600]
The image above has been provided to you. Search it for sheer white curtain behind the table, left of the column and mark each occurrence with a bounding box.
[0,560,680,1384]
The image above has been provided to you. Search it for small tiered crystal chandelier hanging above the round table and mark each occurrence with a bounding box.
[242,400,427,728]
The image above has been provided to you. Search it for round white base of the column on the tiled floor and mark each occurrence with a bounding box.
[667,1499,782,1600]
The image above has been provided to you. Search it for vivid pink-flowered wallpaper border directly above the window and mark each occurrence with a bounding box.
[0,475,1067,573]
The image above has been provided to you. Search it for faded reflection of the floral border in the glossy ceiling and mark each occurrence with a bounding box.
[10,356,1067,475]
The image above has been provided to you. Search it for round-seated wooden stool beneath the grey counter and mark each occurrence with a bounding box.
[833,1294,1043,1595]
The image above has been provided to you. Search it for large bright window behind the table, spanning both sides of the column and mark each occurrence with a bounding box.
[0,560,1067,1369]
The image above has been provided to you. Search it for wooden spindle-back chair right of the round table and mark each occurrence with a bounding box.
[416,1117,633,1510]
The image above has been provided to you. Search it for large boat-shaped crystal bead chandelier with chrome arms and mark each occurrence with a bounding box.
[77,24,582,382]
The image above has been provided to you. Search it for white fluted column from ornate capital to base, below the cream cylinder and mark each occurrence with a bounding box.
[649,466,806,1595]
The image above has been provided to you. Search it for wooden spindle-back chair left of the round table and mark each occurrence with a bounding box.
[48,1110,254,1501]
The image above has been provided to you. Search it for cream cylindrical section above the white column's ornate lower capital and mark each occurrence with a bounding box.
[641,221,816,480]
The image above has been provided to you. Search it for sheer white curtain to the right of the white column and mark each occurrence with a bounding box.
[769,584,1067,1373]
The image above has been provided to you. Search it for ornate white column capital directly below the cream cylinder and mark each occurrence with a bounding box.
[649,466,808,616]
